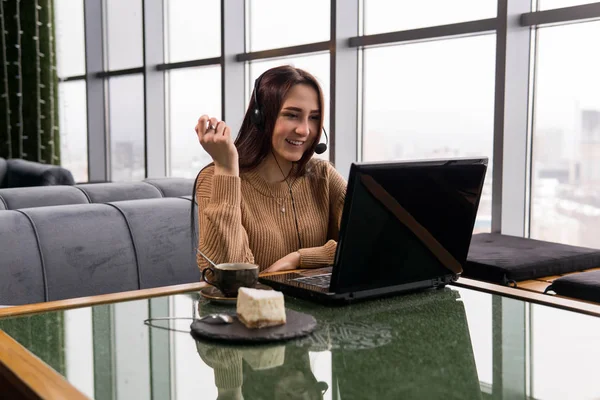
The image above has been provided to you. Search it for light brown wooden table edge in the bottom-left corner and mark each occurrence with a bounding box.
[0,330,88,399]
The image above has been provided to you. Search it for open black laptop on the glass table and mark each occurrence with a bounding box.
[259,157,488,303]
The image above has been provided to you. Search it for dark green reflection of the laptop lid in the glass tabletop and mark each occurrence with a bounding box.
[332,288,482,400]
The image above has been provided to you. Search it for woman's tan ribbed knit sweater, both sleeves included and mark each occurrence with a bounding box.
[196,159,346,271]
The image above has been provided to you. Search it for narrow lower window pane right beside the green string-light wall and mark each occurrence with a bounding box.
[58,80,88,182]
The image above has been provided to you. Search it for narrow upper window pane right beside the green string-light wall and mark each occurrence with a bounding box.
[54,0,85,78]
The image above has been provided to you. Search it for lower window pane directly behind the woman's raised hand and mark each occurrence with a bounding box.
[168,65,221,178]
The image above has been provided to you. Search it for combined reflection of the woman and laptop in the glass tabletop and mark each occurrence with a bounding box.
[196,289,481,399]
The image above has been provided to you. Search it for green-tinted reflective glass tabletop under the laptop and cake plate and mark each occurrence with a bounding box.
[0,287,600,400]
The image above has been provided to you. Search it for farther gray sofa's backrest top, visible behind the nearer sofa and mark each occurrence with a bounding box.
[0,178,194,210]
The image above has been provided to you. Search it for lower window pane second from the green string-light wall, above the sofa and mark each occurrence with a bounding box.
[108,74,146,182]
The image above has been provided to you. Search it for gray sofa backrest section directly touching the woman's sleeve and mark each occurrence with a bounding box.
[109,197,200,289]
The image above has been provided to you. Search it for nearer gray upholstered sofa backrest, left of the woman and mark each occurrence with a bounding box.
[0,198,200,305]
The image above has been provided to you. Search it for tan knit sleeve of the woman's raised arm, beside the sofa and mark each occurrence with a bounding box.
[196,167,254,269]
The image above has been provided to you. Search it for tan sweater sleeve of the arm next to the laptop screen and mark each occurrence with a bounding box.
[298,163,346,268]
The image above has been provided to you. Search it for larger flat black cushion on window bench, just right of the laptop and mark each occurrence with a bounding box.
[463,233,600,284]
